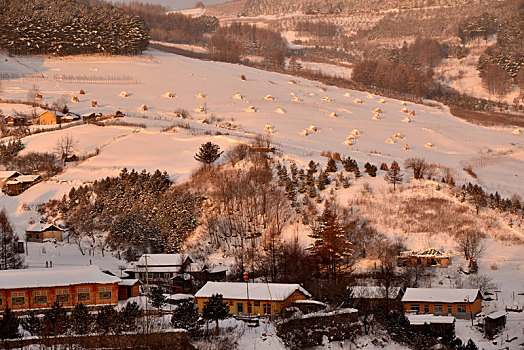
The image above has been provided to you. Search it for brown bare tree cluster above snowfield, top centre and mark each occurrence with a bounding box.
[208,22,287,69]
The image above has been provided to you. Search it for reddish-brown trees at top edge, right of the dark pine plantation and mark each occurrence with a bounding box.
[118,1,218,44]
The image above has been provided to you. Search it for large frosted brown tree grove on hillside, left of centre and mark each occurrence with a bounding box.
[47,169,201,253]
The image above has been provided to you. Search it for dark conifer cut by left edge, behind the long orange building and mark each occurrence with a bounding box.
[0,208,24,270]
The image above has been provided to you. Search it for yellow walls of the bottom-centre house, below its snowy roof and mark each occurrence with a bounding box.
[196,291,306,315]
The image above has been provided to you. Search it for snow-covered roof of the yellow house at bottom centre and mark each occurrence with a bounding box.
[195,282,311,301]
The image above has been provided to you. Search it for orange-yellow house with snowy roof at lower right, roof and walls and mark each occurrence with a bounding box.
[402,288,482,318]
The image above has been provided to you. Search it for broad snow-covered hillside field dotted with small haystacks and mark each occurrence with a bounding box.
[0,51,524,349]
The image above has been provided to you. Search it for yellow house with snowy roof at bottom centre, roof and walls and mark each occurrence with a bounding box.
[195,282,311,315]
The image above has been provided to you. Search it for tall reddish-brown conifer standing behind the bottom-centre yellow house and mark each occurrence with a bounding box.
[308,202,353,281]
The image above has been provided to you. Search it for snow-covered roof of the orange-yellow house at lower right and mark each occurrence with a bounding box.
[402,288,479,303]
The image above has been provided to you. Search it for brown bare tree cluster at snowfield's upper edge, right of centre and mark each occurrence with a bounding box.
[351,59,434,97]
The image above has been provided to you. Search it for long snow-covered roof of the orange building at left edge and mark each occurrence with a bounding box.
[0,265,121,290]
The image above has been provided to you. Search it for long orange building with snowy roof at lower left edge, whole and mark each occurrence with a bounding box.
[0,265,121,310]
